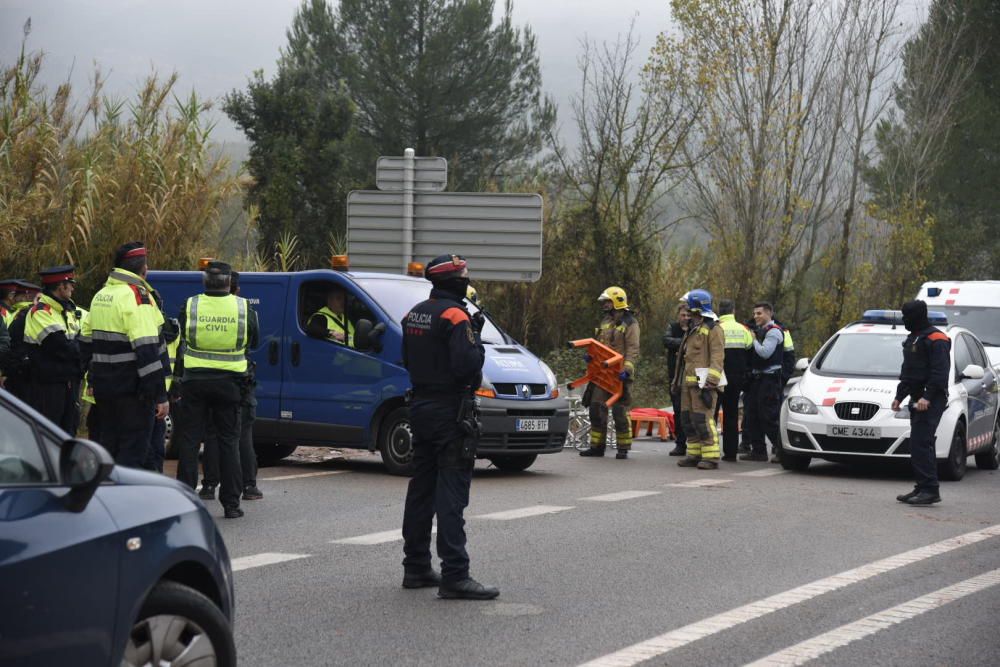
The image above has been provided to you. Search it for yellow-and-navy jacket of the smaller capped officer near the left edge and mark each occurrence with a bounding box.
[24,293,83,382]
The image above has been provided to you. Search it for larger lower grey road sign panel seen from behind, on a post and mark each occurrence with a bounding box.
[347,190,542,282]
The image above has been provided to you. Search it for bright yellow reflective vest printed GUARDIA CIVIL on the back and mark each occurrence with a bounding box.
[184,294,248,373]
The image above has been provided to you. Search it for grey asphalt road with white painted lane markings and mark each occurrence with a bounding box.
[195,439,1000,667]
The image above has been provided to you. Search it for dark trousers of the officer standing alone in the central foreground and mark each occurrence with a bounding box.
[403,396,475,583]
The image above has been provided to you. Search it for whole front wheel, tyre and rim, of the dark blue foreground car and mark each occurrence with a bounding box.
[121,581,236,667]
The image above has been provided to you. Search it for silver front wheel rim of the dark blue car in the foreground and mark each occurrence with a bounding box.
[122,614,217,667]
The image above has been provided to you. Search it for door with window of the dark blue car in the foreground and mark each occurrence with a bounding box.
[0,400,119,667]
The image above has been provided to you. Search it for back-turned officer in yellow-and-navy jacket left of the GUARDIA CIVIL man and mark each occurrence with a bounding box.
[80,241,170,468]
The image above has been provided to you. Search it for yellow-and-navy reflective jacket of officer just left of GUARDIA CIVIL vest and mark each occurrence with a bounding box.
[80,268,169,403]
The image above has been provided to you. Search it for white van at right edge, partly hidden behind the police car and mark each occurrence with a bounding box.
[917,280,1000,371]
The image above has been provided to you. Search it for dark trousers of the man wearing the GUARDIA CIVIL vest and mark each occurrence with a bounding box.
[173,378,243,508]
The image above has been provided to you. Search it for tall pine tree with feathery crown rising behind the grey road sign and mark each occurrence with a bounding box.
[282,0,555,189]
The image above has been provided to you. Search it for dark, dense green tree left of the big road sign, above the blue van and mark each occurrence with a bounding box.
[223,63,360,268]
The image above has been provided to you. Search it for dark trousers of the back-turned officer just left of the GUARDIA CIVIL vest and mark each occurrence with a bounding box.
[94,394,155,468]
